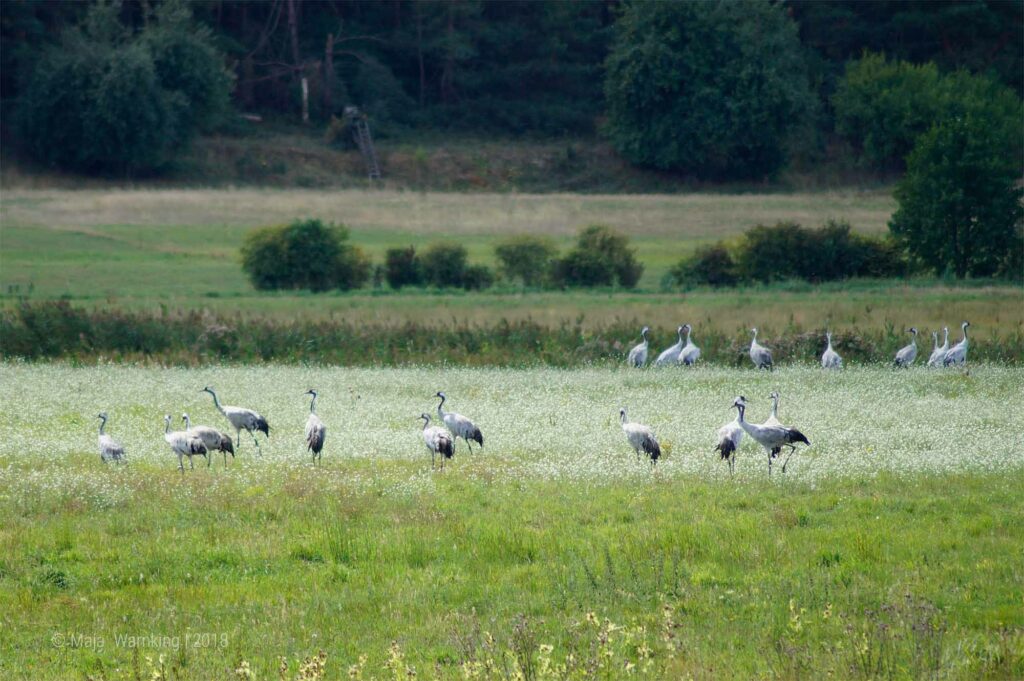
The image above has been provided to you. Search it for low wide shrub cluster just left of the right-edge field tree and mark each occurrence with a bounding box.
[671,220,907,287]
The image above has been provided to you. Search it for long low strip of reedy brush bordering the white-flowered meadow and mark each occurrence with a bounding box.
[8,301,1024,367]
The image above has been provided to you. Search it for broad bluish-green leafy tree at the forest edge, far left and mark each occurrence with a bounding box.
[17,2,230,173]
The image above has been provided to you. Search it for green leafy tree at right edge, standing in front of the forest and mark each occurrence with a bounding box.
[889,113,1024,279]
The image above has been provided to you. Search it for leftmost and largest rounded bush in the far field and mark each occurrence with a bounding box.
[242,219,370,291]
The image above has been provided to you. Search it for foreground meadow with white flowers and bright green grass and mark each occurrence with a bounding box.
[0,364,1024,679]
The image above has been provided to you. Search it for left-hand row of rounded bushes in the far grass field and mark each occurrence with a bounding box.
[242,219,643,291]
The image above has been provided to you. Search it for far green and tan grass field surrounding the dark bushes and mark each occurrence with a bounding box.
[0,189,1024,333]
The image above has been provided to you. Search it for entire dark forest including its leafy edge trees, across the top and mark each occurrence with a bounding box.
[0,0,1024,180]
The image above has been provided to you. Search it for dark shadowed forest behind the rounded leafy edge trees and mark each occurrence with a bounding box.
[0,0,1024,134]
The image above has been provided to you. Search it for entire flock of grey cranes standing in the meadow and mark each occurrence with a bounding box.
[88,322,971,475]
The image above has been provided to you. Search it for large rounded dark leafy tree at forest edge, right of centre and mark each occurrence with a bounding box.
[605,0,814,178]
